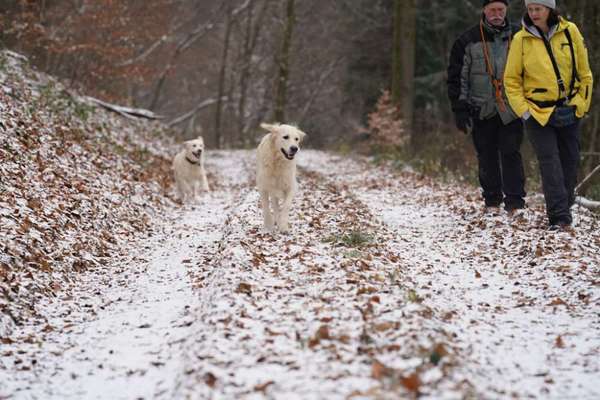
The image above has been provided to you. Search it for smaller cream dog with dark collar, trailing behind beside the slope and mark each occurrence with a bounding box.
[173,136,209,203]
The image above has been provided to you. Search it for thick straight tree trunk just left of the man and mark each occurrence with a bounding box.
[392,0,417,135]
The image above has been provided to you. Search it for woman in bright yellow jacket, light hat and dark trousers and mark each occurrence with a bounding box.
[504,0,592,229]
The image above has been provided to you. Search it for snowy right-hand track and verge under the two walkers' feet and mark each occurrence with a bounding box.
[304,151,600,399]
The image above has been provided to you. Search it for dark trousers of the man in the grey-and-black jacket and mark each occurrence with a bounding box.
[473,115,525,210]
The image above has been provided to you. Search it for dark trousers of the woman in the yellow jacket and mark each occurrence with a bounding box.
[525,118,580,225]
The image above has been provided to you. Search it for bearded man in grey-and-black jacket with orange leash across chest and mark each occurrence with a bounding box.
[447,0,525,212]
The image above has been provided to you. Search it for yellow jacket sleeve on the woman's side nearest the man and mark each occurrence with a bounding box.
[504,35,529,117]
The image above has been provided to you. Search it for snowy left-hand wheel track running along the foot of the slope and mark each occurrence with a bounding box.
[0,152,247,399]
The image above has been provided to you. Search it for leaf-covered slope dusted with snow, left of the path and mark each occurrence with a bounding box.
[0,51,176,337]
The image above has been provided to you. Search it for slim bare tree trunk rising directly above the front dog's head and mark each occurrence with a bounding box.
[275,0,296,122]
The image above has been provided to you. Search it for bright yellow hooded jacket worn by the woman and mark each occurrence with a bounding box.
[504,17,593,126]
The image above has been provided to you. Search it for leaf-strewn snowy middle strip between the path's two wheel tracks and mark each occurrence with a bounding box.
[178,154,466,399]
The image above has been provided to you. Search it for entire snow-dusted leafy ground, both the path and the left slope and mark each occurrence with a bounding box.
[0,53,600,399]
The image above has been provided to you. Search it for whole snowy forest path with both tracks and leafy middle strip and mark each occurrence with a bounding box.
[0,150,600,400]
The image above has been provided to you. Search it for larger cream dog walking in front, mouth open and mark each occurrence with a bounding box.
[256,123,306,232]
